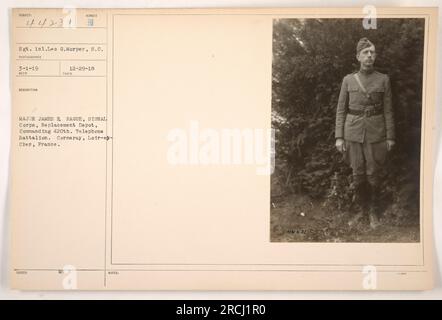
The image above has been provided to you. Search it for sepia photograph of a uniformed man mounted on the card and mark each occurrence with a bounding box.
[270,18,425,243]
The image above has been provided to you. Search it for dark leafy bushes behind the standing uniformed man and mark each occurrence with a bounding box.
[272,19,425,212]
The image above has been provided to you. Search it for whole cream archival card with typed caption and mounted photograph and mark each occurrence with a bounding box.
[9,6,437,290]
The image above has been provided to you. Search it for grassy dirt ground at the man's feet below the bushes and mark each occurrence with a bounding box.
[270,195,419,242]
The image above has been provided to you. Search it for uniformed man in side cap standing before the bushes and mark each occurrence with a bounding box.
[335,38,395,229]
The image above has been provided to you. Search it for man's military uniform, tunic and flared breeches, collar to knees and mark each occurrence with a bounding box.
[335,70,395,175]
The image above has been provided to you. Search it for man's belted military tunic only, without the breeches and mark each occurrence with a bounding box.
[335,71,395,143]
